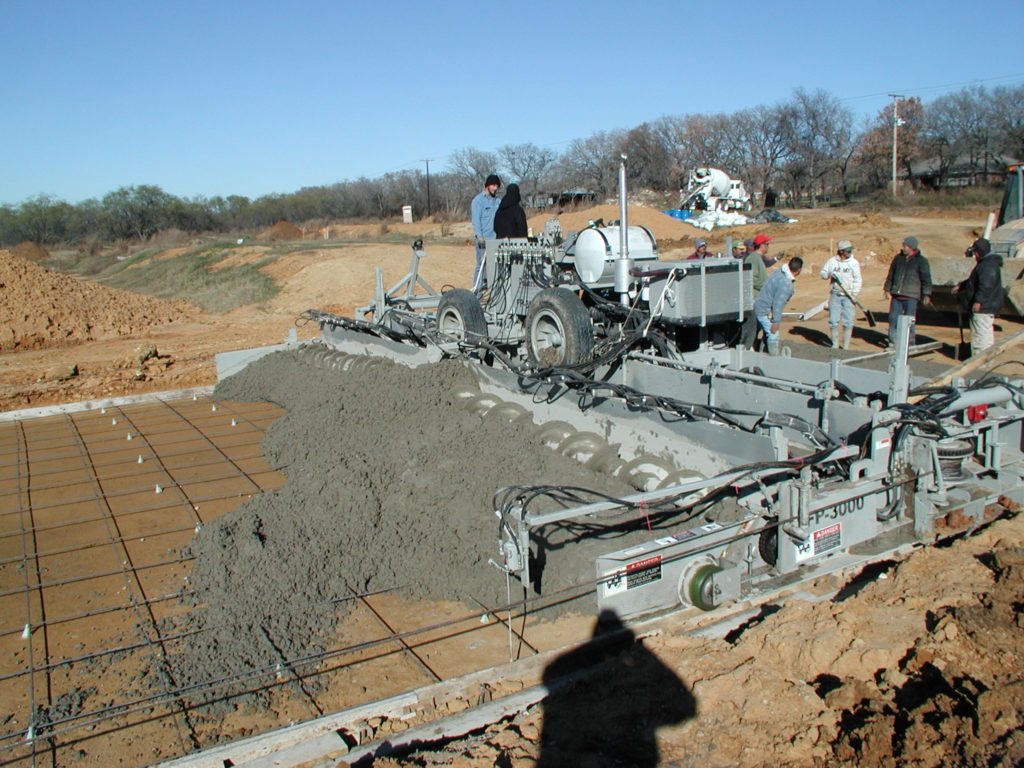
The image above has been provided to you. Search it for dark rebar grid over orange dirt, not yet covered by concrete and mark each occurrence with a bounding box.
[0,401,574,766]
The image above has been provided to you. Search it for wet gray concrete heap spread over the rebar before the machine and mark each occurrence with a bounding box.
[170,351,650,700]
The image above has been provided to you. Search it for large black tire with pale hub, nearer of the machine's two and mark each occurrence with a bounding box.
[526,288,594,368]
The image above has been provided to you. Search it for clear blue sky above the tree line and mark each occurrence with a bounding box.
[0,0,1024,204]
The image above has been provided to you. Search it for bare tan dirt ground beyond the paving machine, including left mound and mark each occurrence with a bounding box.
[0,205,1024,411]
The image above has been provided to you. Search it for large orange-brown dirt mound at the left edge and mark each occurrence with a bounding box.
[0,251,193,352]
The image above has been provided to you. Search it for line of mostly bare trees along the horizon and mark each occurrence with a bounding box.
[0,85,1024,245]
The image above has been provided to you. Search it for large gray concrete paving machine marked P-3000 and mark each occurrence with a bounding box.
[290,166,1024,617]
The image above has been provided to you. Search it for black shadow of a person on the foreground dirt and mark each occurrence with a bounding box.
[537,610,696,768]
